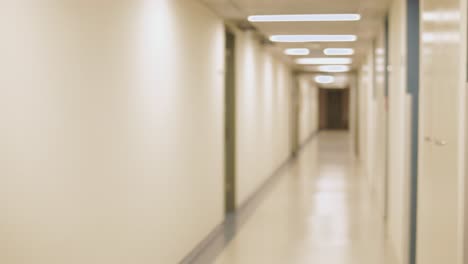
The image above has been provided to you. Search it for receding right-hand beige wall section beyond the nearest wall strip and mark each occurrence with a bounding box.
[352,21,387,227]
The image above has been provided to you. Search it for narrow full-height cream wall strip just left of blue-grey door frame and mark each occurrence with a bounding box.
[387,0,410,264]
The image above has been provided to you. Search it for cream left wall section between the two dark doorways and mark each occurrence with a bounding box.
[236,32,293,205]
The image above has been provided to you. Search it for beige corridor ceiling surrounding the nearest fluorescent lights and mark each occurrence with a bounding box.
[200,0,388,71]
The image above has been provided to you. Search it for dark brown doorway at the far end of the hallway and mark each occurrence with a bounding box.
[320,89,349,130]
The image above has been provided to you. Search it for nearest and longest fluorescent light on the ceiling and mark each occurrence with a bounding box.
[248,14,361,22]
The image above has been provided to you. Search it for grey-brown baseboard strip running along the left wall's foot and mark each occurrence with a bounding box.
[179,131,320,264]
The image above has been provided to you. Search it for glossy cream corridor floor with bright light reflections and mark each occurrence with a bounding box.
[215,132,395,264]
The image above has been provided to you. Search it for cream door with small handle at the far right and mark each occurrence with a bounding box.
[416,0,466,264]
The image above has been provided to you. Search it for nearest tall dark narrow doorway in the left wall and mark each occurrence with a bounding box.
[224,30,236,214]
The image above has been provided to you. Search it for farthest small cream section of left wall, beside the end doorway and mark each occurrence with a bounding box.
[299,75,319,144]
